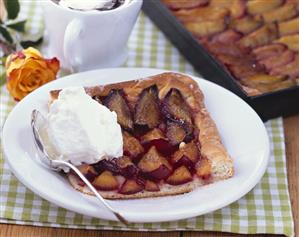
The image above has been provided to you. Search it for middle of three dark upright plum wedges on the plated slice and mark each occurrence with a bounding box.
[134,86,160,129]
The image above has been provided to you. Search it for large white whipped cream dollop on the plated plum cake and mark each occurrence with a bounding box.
[47,87,123,165]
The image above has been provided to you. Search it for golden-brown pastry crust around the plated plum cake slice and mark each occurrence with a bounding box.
[51,72,234,199]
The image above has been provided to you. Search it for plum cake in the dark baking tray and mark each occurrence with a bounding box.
[162,0,299,96]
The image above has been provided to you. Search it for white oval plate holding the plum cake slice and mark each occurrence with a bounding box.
[3,68,269,222]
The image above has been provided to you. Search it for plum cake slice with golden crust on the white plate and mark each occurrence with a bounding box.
[51,73,233,199]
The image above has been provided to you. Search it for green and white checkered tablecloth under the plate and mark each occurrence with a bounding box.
[0,0,294,236]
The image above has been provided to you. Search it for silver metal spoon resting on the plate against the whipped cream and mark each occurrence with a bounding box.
[31,110,128,225]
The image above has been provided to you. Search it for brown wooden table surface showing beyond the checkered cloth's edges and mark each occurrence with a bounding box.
[0,116,299,237]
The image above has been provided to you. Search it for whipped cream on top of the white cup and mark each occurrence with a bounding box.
[59,0,116,11]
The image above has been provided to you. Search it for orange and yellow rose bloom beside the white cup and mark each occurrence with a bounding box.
[5,47,59,101]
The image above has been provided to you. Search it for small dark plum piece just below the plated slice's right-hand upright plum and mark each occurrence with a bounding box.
[166,121,187,146]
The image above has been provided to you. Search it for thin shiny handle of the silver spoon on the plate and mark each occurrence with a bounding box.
[52,160,128,225]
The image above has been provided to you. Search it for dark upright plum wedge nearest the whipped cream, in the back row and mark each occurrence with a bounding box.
[104,90,133,130]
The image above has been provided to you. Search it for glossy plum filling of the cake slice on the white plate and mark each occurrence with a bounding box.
[72,86,211,195]
